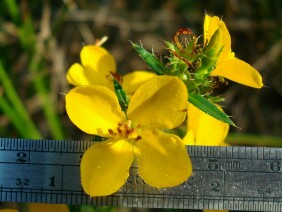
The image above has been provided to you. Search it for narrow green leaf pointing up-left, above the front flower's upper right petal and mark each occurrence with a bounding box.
[132,43,167,75]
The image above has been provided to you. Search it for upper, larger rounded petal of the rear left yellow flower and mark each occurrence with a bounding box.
[80,45,116,87]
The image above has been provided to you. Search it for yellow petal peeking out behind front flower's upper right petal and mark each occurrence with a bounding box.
[122,71,155,95]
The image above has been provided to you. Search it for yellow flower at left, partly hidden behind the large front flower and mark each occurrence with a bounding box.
[66,44,155,95]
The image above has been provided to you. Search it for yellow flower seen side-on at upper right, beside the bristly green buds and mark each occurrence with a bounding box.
[204,14,263,88]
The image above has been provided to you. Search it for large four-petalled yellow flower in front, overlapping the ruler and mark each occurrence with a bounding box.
[66,76,192,196]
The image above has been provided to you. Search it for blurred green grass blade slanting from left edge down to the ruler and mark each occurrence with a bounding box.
[0,61,41,138]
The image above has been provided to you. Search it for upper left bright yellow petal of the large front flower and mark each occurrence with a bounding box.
[66,85,126,137]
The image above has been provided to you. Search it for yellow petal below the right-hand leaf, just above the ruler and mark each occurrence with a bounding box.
[185,103,229,146]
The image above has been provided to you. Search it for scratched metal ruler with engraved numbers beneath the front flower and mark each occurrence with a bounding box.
[0,138,282,211]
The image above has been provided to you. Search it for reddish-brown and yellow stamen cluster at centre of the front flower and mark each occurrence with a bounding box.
[108,120,141,140]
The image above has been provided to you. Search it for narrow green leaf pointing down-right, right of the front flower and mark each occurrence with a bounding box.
[188,93,236,127]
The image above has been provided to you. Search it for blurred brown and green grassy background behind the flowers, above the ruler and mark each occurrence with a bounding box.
[0,0,282,210]
